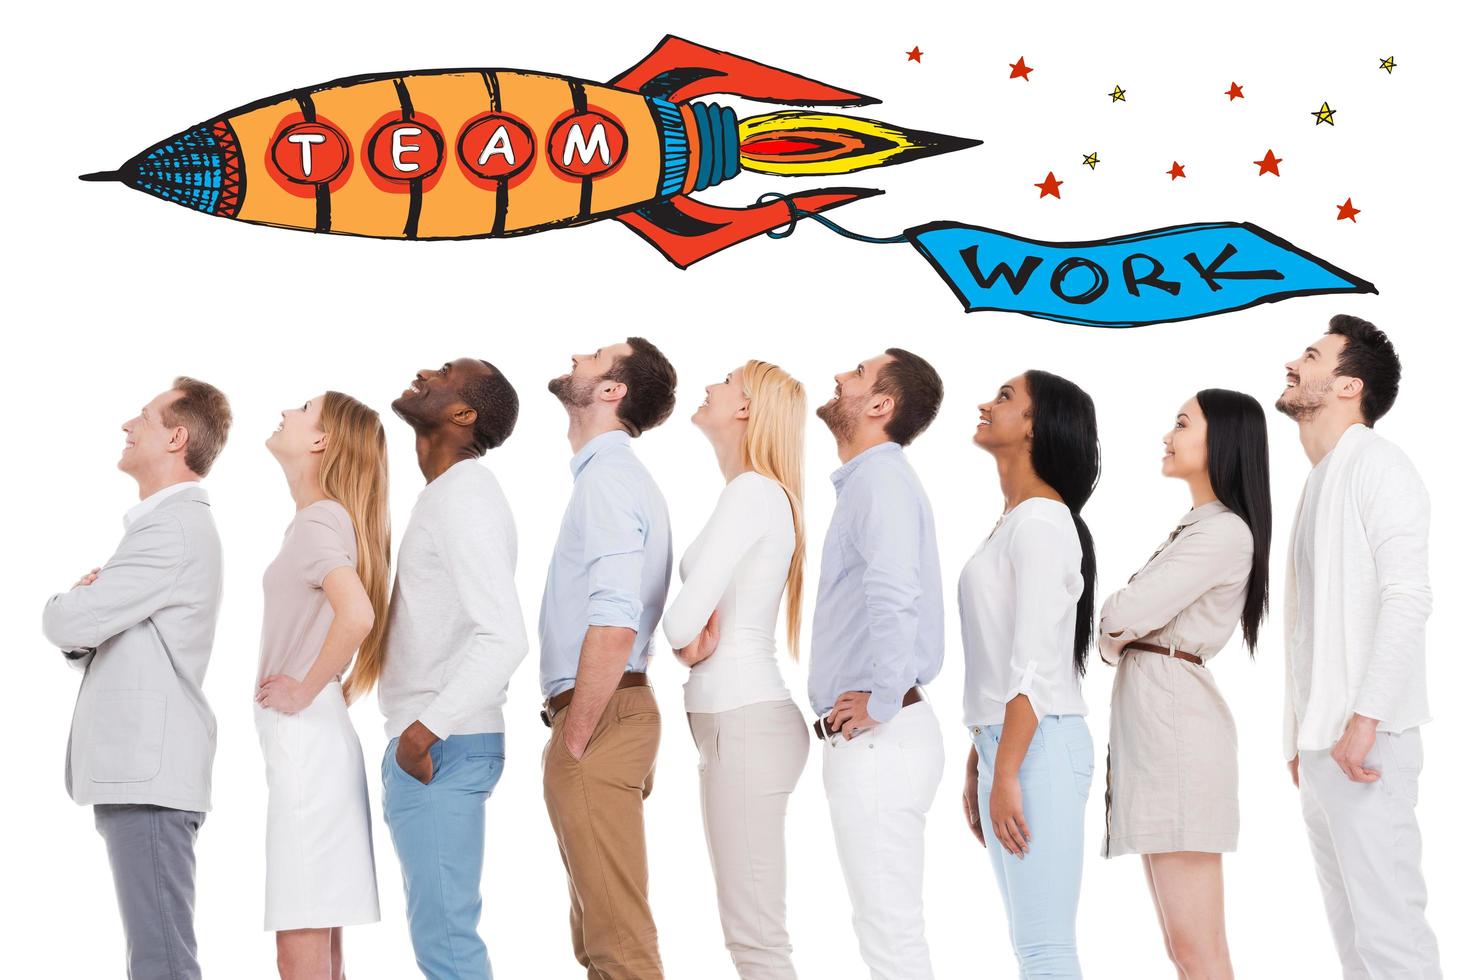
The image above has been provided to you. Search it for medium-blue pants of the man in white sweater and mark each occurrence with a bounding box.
[382,732,505,980]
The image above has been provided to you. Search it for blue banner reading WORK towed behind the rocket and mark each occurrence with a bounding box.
[903,222,1376,326]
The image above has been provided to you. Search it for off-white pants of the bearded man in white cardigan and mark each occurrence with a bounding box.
[1299,729,1444,980]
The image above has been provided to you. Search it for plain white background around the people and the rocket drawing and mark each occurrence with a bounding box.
[0,3,1469,980]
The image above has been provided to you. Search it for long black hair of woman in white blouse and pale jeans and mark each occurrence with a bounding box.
[1025,370,1102,674]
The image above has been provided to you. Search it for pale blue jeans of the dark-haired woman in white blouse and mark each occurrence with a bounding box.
[970,714,1093,980]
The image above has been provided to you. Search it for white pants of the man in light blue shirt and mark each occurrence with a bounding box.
[821,701,943,980]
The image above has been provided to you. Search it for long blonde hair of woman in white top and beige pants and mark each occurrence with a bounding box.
[740,360,806,660]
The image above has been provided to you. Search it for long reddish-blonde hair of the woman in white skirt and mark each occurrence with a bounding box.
[320,391,392,704]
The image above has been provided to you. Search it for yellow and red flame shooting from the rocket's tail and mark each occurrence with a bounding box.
[739,110,981,176]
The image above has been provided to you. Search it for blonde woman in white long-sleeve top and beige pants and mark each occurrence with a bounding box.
[663,360,811,980]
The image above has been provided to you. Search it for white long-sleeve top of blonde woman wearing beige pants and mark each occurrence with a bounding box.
[663,472,796,713]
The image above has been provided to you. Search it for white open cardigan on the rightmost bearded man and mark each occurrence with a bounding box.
[1285,425,1432,760]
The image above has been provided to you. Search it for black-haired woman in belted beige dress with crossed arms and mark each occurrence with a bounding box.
[1099,388,1271,980]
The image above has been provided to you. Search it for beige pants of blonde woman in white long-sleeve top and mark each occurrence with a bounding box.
[689,699,811,980]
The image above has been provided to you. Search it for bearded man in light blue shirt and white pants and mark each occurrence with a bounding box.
[808,347,943,979]
